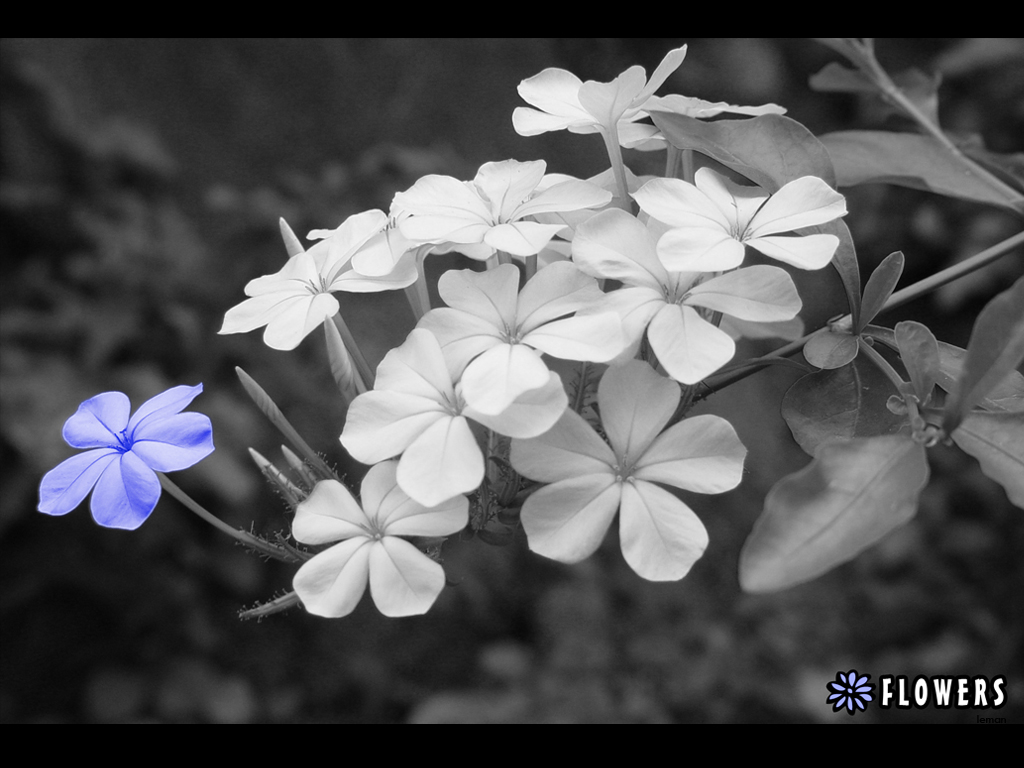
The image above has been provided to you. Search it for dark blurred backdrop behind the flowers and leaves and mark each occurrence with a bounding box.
[0,38,1024,723]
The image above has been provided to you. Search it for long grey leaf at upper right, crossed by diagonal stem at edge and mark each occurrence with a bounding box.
[821,131,1024,213]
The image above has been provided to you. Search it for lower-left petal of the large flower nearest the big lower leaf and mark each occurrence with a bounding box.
[520,475,622,563]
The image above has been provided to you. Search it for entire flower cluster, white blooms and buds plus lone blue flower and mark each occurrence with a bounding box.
[39,46,846,616]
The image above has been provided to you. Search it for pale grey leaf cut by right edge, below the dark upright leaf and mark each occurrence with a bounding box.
[951,412,1024,509]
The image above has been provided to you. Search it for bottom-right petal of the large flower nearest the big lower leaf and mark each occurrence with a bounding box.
[618,480,708,582]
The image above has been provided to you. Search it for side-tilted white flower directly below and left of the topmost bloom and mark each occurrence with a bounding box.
[394,160,611,260]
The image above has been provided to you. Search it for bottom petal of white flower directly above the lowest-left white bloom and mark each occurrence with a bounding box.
[397,416,483,507]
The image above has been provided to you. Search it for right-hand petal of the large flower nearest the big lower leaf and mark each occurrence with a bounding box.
[633,414,746,494]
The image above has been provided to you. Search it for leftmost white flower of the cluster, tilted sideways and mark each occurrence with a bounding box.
[219,210,417,350]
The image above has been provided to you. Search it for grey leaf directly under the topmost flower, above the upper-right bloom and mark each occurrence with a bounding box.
[650,112,836,194]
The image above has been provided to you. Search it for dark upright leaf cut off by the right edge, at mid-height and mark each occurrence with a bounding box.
[943,278,1024,433]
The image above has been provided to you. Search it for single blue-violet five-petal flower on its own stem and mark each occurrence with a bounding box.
[38,384,213,530]
